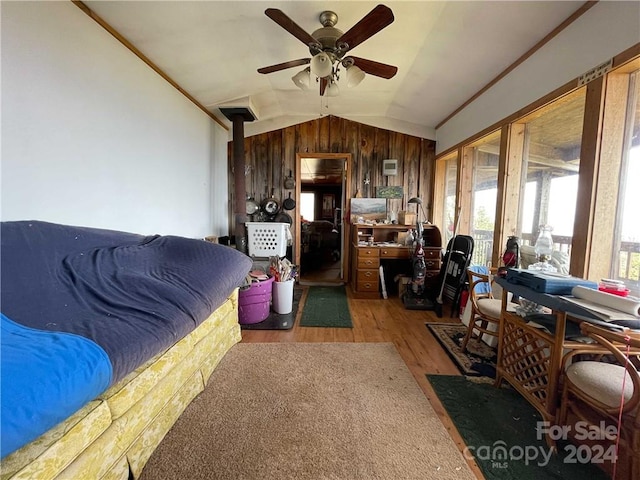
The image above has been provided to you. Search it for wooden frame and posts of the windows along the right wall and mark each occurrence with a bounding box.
[432,43,640,280]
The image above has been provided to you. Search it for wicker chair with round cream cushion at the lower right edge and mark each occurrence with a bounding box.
[557,322,640,479]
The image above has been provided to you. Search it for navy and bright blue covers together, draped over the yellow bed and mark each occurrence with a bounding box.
[0,221,251,457]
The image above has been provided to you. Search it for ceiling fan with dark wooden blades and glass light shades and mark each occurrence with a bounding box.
[258,5,398,96]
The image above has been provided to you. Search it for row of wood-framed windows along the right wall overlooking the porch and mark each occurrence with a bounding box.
[433,46,640,282]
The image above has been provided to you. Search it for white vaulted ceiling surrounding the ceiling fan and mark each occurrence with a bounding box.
[85,1,583,138]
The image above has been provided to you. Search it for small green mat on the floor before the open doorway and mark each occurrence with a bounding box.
[300,285,353,328]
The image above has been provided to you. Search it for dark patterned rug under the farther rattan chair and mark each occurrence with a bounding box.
[426,323,498,378]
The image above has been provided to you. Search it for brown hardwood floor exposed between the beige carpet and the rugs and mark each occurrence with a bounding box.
[242,287,484,479]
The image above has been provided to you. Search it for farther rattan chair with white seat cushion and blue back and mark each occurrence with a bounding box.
[461,268,502,352]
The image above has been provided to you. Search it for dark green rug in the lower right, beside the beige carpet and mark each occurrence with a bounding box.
[427,375,610,480]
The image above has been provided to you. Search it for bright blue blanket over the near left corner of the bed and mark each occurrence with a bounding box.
[0,314,111,457]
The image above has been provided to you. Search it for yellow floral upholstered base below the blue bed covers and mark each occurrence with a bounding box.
[0,289,241,480]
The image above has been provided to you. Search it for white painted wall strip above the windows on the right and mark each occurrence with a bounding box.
[436,1,640,153]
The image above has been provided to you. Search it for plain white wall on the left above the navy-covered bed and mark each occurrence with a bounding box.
[0,2,228,237]
